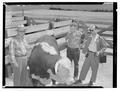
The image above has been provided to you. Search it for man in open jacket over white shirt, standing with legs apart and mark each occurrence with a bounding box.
[76,25,107,86]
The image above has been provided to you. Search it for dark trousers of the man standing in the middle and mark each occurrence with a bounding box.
[67,47,80,77]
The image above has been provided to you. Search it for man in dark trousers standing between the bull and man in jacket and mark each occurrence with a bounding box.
[66,20,82,80]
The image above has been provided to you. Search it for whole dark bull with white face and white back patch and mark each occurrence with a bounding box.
[27,35,74,86]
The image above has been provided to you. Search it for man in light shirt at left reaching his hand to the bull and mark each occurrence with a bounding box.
[9,26,38,86]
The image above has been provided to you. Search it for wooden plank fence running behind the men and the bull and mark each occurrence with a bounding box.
[5,12,113,55]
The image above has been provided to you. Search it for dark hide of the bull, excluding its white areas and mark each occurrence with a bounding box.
[28,35,60,82]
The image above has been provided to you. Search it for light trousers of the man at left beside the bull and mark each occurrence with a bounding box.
[12,56,27,86]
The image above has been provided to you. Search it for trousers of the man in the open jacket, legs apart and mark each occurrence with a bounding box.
[79,52,99,82]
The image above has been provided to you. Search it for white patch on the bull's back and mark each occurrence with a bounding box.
[40,42,58,55]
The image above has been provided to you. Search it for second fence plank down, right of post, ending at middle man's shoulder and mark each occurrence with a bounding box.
[54,26,70,36]
